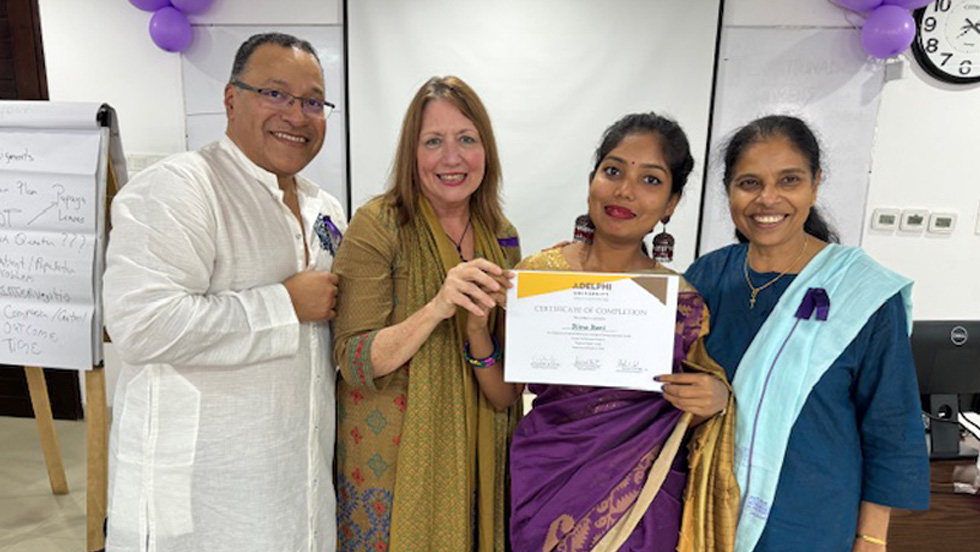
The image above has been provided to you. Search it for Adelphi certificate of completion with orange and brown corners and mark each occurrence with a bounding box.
[504,270,680,391]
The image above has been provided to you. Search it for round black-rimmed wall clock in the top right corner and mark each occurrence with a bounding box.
[912,0,980,84]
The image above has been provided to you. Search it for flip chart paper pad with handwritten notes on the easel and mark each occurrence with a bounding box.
[0,102,121,370]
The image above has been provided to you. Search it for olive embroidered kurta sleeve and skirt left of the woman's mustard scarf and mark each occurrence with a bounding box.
[334,196,408,550]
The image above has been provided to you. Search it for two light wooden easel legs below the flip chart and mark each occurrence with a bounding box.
[24,366,109,552]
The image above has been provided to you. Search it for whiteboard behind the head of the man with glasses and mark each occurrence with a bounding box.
[181,25,347,210]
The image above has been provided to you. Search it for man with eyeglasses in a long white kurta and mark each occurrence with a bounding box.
[104,33,346,552]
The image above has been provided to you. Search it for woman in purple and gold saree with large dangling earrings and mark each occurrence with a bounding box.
[510,113,738,552]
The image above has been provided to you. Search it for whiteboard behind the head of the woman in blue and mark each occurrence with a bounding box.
[700,27,884,254]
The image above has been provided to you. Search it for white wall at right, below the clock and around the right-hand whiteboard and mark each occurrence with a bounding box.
[718,0,980,320]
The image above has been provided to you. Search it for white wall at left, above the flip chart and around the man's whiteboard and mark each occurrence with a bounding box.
[38,0,342,405]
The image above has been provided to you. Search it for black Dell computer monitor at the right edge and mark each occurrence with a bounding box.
[912,320,980,458]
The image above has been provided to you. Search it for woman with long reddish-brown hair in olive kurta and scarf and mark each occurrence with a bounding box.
[334,77,520,552]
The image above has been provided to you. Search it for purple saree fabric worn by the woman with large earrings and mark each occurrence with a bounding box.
[510,287,707,552]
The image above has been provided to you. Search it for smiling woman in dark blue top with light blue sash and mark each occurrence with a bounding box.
[686,116,929,551]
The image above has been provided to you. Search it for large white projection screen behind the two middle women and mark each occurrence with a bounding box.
[347,0,719,267]
